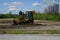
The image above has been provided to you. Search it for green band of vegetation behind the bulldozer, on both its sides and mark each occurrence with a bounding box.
[0,13,60,21]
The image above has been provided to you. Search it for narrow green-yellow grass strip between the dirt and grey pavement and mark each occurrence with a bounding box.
[0,30,60,34]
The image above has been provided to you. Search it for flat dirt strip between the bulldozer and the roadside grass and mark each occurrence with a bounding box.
[0,25,60,30]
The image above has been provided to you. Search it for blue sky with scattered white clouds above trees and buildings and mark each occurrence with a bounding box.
[0,0,60,14]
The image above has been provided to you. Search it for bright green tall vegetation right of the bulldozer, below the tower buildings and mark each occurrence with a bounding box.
[34,13,60,21]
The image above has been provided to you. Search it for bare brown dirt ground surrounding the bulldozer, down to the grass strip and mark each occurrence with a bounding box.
[0,19,60,30]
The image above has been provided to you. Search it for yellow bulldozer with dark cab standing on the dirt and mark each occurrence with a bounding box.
[13,10,35,25]
